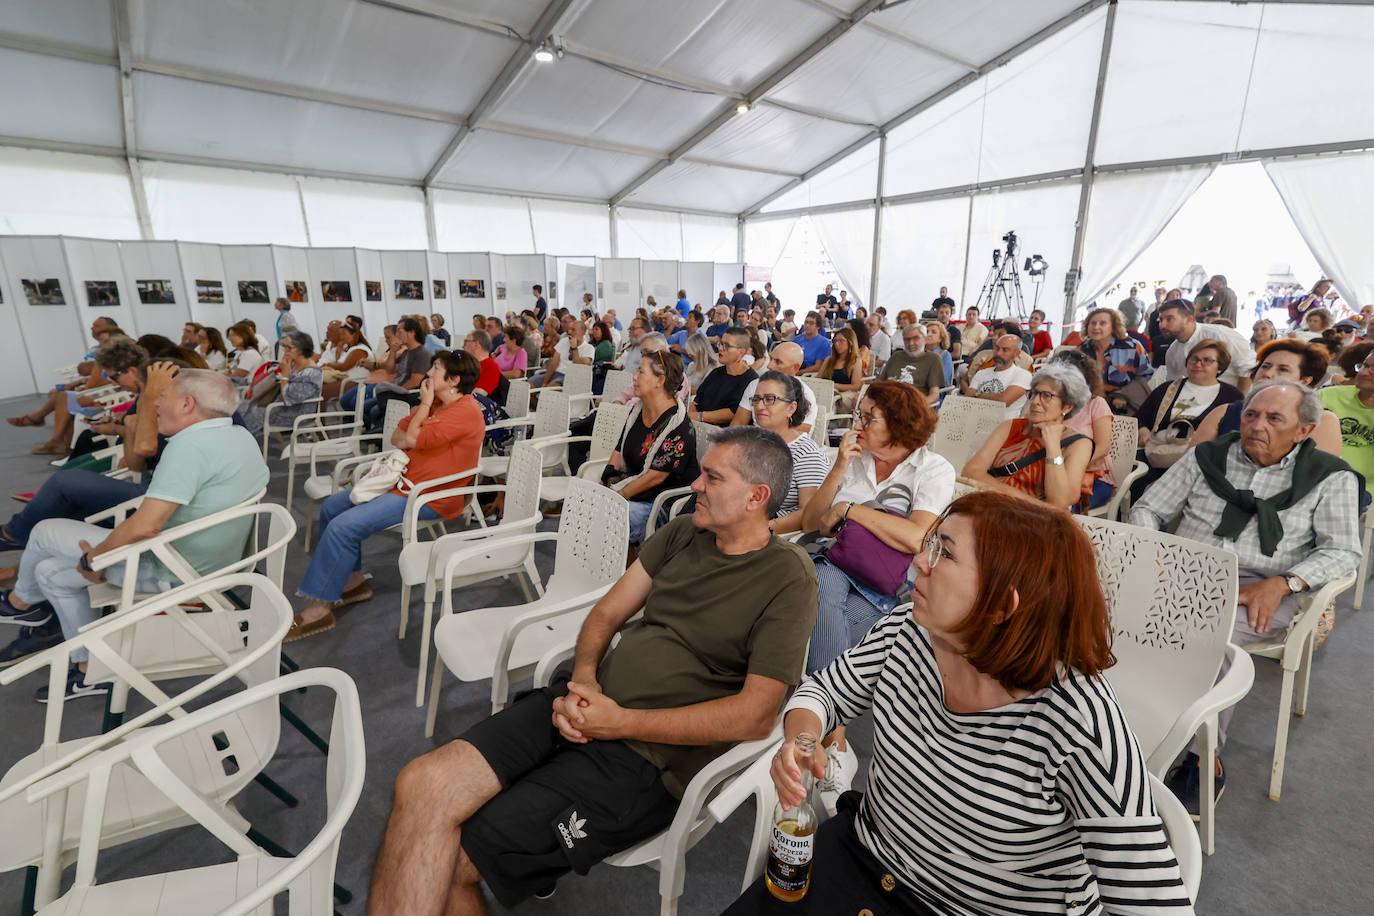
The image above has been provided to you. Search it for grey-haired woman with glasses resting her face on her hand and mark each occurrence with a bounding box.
[963,361,1092,509]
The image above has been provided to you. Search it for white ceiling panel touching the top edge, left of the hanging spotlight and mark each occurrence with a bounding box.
[133,0,518,114]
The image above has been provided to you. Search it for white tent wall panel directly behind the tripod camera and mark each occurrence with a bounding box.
[949,181,1079,311]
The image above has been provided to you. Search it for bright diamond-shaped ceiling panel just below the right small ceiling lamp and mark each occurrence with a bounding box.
[690,104,867,177]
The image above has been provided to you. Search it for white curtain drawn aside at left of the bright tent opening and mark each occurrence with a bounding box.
[1077,165,1213,315]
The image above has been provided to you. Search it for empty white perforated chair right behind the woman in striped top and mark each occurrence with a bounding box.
[1079,516,1254,856]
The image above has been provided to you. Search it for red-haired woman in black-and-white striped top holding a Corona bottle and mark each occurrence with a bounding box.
[727,492,1193,916]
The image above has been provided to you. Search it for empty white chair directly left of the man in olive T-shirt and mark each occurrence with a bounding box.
[420,479,629,736]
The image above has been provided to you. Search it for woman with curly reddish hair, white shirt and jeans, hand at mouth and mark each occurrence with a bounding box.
[801,380,955,809]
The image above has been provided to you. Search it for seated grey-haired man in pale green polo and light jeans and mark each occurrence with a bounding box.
[0,369,268,702]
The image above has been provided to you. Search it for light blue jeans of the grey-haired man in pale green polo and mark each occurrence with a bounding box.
[14,519,166,662]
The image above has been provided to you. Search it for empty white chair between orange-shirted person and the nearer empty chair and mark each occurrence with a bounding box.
[398,442,541,706]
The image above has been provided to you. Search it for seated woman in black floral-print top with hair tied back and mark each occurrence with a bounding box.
[602,350,701,544]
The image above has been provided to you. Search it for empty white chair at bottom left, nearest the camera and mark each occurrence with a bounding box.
[19,667,365,916]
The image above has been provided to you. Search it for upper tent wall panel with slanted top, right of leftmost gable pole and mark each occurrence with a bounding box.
[884,81,985,195]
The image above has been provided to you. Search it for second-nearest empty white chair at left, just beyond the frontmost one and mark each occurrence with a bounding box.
[0,573,294,912]
